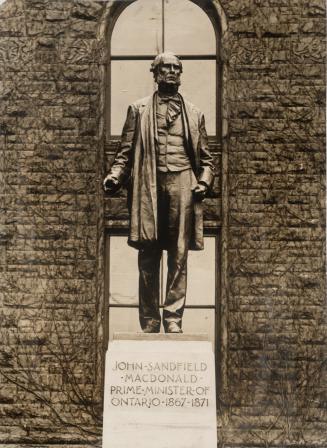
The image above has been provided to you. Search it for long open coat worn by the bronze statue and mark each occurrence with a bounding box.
[111,93,214,250]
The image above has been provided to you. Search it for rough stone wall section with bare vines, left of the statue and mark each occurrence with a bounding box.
[0,0,105,443]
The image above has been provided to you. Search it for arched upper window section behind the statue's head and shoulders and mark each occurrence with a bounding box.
[106,0,221,142]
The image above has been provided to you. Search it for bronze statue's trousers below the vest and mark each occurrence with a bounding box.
[138,169,197,331]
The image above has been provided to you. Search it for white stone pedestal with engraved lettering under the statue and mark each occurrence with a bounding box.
[103,340,217,448]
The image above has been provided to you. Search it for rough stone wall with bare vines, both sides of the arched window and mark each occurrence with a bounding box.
[0,0,327,447]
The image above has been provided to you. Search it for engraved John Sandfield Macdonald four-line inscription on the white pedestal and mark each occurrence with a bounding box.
[110,359,212,408]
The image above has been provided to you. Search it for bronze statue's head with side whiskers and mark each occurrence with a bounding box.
[150,51,183,87]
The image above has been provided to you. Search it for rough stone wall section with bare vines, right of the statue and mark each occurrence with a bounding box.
[221,0,327,446]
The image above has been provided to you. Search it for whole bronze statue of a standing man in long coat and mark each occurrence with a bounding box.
[104,52,214,333]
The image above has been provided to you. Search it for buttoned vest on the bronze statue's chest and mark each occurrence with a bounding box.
[156,102,191,172]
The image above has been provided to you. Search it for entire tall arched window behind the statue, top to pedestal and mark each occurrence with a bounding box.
[105,0,221,354]
